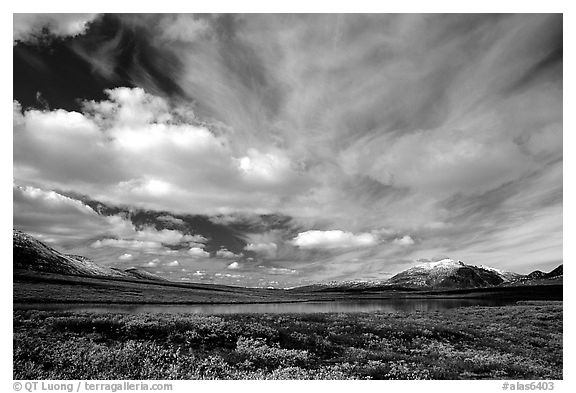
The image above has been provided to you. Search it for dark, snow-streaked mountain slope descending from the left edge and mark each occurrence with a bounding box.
[12,229,167,281]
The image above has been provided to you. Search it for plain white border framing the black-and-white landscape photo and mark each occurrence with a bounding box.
[0,0,576,393]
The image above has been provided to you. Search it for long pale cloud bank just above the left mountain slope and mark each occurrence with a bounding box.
[13,181,224,278]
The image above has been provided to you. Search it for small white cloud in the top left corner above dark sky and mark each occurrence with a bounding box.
[13,14,97,42]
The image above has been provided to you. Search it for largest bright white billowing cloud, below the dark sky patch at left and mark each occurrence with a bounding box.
[14,88,304,214]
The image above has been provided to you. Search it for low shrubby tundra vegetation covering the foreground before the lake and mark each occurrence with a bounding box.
[13,302,562,380]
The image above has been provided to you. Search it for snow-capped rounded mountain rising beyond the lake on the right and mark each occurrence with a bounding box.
[388,259,505,289]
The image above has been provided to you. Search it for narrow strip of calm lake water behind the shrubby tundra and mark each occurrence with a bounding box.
[14,299,514,314]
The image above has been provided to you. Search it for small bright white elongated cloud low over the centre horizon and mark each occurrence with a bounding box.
[292,230,378,249]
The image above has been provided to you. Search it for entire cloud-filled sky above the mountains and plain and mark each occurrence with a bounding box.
[13,14,563,287]
